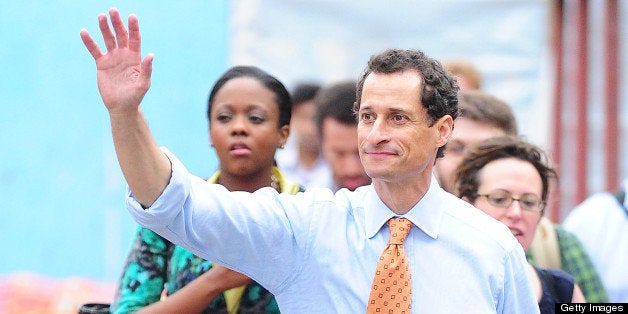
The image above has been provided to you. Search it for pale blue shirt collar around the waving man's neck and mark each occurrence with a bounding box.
[364,175,444,239]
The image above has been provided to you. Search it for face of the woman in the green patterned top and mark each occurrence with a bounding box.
[209,77,290,176]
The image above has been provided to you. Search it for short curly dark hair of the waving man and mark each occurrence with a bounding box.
[353,49,459,158]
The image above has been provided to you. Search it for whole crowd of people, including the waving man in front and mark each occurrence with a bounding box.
[72,9,628,313]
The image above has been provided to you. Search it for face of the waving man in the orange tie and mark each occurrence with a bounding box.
[358,70,453,184]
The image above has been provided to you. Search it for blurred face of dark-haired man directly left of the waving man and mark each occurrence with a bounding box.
[321,117,371,191]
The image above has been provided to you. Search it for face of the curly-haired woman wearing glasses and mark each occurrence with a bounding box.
[473,158,543,251]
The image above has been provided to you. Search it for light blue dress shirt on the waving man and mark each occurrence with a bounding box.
[127,149,539,314]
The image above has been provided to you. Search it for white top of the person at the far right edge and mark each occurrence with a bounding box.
[563,180,628,302]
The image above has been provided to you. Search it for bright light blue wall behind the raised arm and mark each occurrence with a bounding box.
[0,0,229,281]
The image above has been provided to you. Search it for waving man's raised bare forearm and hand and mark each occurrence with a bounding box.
[81,9,171,207]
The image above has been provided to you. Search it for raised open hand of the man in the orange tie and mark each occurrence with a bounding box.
[81,8,153,114]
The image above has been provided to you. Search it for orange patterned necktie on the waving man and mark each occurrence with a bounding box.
[366,218,412,314]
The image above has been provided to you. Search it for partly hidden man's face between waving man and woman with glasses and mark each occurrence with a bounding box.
[434,117,506,193]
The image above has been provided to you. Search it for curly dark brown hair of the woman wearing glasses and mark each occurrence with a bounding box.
[454,136,558,213]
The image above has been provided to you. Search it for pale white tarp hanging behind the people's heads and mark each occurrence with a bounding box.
[230,0,551,146]
